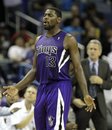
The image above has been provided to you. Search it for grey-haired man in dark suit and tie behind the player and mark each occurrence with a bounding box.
[74,39,112,130]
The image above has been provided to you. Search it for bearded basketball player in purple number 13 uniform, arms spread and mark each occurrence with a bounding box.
[4,8,95,130]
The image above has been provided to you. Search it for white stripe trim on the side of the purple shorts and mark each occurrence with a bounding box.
[54,89,65,130]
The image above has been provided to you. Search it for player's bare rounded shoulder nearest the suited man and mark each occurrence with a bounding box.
[64,33,77,50]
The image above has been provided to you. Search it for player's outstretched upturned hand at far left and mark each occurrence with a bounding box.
[3,86,18,97]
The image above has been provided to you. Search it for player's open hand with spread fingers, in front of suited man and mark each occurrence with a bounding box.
[84,95,96,112]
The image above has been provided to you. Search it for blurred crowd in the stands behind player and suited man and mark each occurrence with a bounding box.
[0,0,112,86]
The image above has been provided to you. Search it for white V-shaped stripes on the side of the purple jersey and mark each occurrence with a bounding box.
[58,49,70,72]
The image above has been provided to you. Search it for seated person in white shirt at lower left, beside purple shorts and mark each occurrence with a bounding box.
[6,85,37,130]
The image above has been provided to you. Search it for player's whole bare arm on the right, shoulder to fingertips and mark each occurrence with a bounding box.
[64,34,95,111]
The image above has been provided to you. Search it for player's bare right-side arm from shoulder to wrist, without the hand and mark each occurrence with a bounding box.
[65,35,88,96]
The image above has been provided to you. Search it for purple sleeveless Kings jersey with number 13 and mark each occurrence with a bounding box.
[36,31,70,84]
